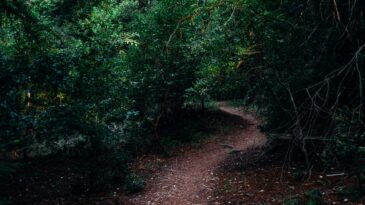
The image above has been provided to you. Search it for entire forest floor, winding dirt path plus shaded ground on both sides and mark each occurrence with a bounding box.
[4,102,365,205]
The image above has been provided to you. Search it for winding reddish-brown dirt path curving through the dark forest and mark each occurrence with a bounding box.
[128,103,266,205]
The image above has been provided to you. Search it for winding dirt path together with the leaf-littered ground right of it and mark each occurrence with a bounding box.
[126,102,365,205]
